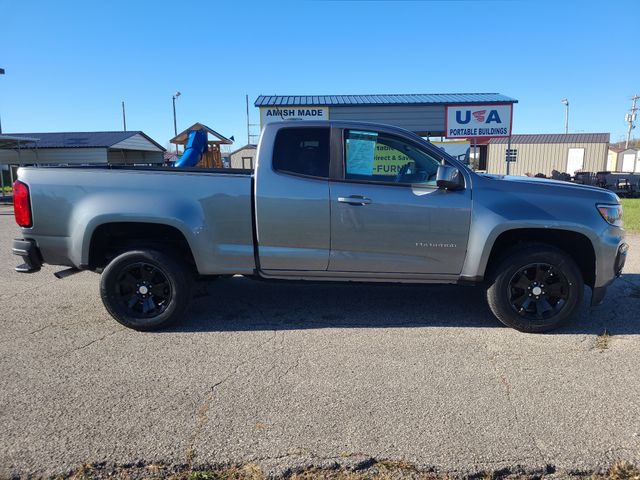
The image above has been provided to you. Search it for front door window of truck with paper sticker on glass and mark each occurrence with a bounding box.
[344,130,440,186]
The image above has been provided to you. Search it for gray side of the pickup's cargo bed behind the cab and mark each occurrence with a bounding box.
[19,166,255,275]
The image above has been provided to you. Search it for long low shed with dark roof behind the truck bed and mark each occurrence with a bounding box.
[0,131,165,165]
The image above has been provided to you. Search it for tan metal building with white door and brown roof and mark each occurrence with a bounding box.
[487,133,609,176]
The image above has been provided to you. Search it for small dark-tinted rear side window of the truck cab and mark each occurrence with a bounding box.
[273,128,329,178]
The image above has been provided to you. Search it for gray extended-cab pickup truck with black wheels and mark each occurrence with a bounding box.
[13,121,627,332]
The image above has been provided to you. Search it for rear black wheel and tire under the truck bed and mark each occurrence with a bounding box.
[100,250,193,331]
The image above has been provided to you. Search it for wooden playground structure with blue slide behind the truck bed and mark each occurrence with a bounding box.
[170,123,233,168]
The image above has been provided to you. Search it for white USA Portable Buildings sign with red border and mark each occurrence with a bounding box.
[445,104,513,138]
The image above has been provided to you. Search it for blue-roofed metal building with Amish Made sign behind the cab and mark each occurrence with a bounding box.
[254,93,517,137]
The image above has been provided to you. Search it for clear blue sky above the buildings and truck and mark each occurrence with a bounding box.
[0,0,640,146]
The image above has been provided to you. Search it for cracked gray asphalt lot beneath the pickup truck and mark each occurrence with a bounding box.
[0,207,640,477]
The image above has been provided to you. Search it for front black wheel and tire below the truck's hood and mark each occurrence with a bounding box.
[487,245,584,333]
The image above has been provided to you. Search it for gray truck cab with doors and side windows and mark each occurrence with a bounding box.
[254,122,472,281]
